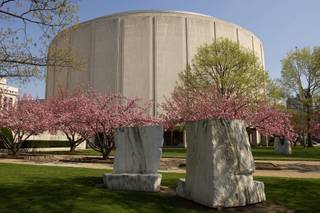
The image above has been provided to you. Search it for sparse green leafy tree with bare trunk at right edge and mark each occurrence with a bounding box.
[281,47,320,147]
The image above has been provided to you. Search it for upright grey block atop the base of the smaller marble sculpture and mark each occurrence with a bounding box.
[113,126,163,174]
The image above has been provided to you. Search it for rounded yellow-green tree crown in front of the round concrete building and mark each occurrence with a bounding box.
[180,39,268,98]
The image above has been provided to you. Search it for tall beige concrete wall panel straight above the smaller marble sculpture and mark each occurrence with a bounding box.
[122,16,152,101]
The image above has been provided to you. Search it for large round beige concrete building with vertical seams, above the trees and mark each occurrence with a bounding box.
[46,11,264,113]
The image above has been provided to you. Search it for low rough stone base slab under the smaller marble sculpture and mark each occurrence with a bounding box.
[103,173,162,192]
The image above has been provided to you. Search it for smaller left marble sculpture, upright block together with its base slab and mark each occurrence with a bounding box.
[104,126,163,191]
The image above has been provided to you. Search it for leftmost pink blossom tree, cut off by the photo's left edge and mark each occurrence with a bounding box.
[0,96,51,155]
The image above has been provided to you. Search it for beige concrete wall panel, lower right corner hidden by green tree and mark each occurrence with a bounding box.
[155,16,186,103]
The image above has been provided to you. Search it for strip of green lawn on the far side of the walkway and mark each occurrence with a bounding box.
[35,146,320,160]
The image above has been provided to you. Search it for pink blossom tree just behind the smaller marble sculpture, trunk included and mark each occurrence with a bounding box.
[81,91,159,159]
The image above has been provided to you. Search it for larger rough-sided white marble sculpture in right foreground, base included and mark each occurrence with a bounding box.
[177,120,266,208]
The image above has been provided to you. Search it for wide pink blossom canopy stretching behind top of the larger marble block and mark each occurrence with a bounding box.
[161,87,296,140]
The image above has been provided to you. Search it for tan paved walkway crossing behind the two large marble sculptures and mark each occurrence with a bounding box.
[0,156,320,179]
